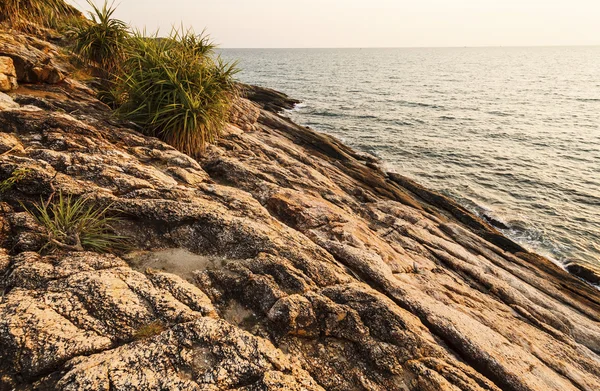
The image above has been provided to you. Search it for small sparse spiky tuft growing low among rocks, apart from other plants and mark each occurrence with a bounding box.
[26,192,125,253]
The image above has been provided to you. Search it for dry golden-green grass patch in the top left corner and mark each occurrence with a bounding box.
[0,0,81,30]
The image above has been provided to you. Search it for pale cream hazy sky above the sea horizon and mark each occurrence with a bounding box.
[70,0,600,48]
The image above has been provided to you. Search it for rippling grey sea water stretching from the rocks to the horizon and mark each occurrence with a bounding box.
[222,47,600,272]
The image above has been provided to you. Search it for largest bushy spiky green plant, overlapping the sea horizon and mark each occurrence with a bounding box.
[116,29,237,156]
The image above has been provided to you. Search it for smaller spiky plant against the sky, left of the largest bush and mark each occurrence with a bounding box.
[68,0,129,75]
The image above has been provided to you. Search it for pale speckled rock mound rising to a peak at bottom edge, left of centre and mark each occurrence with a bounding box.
[56,318,322,391]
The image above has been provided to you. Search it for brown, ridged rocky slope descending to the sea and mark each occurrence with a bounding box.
[0,27,600,391]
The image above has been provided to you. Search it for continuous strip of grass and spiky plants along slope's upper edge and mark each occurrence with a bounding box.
[0,0,238,157]
